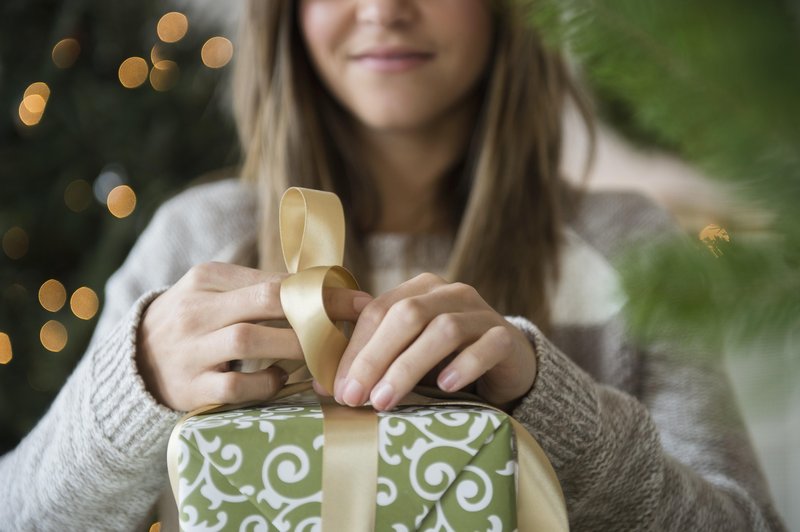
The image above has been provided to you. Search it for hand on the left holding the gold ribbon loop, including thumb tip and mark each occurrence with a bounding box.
[136,262,371,411]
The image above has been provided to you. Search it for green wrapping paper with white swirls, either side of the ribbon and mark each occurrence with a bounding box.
[173,402,516,531]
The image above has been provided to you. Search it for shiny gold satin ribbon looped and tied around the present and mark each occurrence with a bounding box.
[167,188,569,532]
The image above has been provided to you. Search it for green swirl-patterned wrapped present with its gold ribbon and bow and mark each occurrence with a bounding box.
[168,188,568,532]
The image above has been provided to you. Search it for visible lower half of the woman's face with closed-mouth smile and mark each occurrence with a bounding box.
[298,0,494,132]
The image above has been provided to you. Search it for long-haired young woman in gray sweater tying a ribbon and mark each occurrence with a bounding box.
[0,0,782,530]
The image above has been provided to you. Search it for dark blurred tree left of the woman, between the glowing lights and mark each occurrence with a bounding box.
[0,0,239,454]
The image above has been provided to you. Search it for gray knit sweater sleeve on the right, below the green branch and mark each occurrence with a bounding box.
[509,318,784,530]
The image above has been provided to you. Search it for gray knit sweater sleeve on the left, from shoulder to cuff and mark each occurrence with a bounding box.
[0,182,254,531]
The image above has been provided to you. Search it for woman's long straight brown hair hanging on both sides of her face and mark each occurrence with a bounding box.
[234,0,590,328]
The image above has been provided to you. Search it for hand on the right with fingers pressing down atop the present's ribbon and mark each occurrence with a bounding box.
[334,273,536,410]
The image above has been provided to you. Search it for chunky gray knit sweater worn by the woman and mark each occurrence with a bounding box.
[0,180,783,531]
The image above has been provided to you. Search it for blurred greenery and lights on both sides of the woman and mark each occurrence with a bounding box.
[0,0,800,529]
